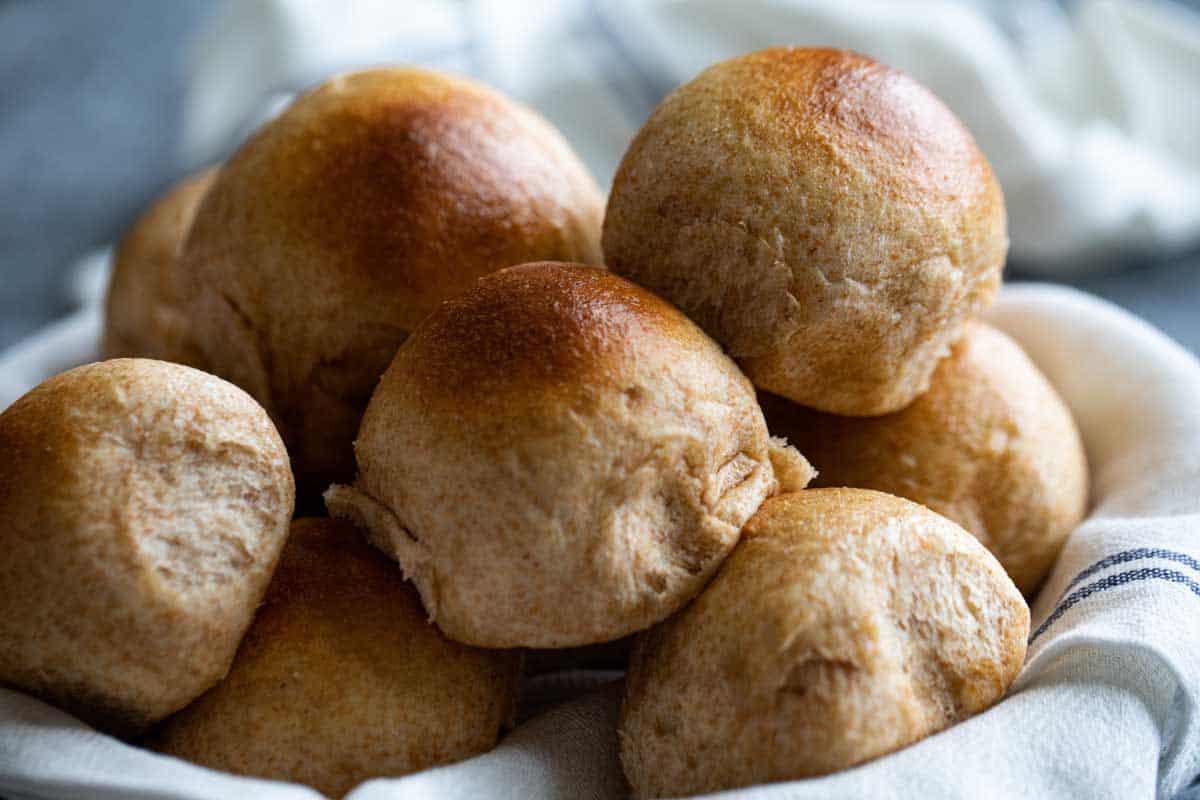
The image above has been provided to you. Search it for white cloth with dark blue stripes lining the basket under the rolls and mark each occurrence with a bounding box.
[0,285,1200,800]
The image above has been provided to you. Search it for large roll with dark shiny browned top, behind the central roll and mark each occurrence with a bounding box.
[175,70,604,493]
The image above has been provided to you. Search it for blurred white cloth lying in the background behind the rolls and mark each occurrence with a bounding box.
[182,0,1200,275]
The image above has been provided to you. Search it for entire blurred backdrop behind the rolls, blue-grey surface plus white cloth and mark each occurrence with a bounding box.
[0,0,1200,353]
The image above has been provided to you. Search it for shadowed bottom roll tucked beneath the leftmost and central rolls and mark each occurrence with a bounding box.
[150,518,520,798]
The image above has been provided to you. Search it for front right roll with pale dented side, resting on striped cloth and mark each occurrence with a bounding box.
[618,489,1030,798]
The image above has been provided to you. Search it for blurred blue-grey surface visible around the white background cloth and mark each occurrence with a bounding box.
[0,0,1200,353]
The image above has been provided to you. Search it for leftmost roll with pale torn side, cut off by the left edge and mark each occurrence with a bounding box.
[0,359,294,735]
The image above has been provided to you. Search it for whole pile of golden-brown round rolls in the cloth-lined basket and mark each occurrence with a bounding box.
[0,48,1087,798]
